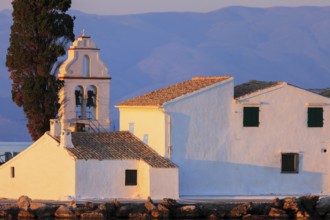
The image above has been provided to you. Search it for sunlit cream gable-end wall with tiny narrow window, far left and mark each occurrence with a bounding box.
[0,134,75,200]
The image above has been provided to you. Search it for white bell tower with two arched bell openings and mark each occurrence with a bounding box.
[58,32,111,132]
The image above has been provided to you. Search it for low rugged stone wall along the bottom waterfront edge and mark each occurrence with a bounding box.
[0,195,330,219]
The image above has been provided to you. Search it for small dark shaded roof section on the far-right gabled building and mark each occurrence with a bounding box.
[234,80,284,99]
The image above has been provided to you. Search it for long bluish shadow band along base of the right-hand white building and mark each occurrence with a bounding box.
[173,157,325,196]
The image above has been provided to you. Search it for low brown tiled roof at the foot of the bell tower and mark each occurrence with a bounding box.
[67,131,177,168]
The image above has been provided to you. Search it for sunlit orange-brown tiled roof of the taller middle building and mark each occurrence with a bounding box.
[116,76,231,107]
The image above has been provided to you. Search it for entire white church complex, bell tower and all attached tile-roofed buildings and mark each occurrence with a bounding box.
[0,36,330,200]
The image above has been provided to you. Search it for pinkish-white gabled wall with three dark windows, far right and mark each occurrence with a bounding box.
[228,84,330,195]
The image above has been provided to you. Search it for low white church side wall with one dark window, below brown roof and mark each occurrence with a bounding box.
[76,160,178,199]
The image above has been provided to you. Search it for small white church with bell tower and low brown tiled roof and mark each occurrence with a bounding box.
[0,36,178,200]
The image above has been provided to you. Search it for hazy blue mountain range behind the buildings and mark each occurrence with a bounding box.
[0,7,330,141]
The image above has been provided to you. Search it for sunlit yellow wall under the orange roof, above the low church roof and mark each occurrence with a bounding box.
[119,107,168,157]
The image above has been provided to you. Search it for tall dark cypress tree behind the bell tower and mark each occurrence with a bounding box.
[6,0,74,140]
